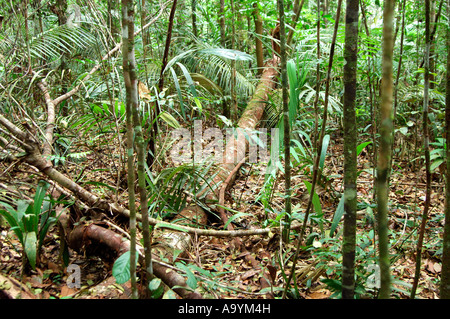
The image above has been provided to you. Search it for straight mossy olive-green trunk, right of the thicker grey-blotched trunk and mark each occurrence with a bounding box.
[377,0,395,299]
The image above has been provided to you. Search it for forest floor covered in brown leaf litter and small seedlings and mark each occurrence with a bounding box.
[0,127,444,299]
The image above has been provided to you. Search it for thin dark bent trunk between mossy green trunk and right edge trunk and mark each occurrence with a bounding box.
[411,0,431,299]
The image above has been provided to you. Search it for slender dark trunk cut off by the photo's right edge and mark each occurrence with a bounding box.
[440,1,450,299]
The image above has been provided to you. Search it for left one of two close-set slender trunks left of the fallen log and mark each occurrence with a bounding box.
[122,0,138,299]
